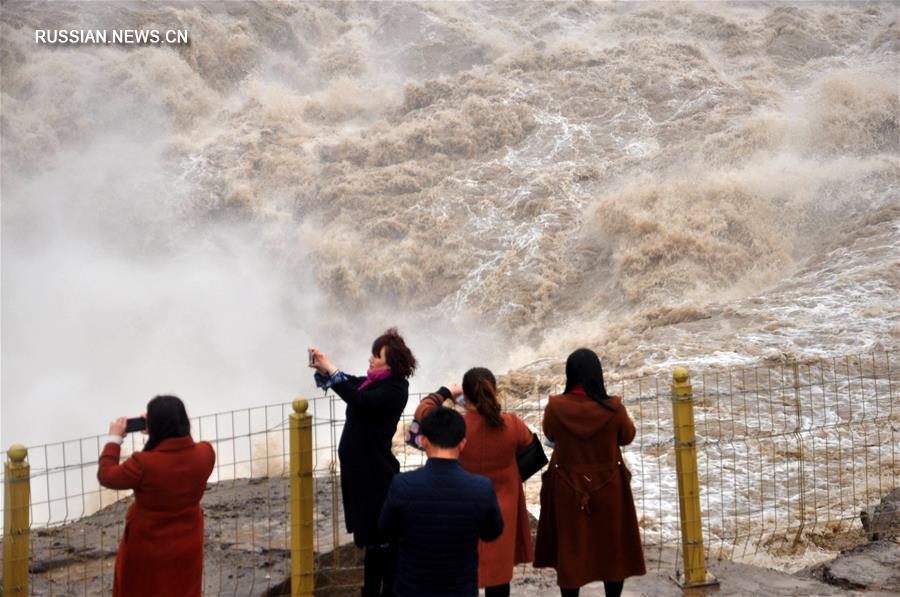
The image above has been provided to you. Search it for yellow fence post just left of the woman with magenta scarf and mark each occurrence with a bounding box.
[290,398,315,597]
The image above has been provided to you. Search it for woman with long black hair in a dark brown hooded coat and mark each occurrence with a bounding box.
[534,348,646,597]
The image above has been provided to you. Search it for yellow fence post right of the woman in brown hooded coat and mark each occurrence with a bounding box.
[672,367,719,588]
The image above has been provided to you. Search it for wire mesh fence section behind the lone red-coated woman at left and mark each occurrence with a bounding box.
[3,403,304,596]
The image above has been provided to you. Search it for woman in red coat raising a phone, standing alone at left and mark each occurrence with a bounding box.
[97,396,216,597]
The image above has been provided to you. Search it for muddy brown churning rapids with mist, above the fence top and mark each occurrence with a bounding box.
[0,2,900,445]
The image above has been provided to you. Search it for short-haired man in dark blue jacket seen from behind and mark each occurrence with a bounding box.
[380,407,503,597]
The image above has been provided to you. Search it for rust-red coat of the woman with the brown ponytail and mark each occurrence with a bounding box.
[416,394,534,587]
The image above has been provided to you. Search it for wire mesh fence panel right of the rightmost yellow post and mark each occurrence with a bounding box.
[694,352,900,569]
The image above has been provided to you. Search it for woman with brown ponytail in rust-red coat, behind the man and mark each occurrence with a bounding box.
[416,367,534,597]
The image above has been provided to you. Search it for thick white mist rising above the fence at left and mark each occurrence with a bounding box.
[2,127,505,443]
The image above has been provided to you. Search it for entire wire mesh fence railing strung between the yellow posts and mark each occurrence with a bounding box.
[0,352,900,596]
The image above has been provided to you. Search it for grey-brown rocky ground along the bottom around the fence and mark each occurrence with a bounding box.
[10,477,900,597]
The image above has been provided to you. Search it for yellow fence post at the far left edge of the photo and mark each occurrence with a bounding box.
[3,444,31,597]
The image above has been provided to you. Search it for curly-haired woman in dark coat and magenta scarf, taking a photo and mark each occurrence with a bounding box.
[309,328,416,597]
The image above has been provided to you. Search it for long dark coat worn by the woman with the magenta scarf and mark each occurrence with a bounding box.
[331,375,409,547]
